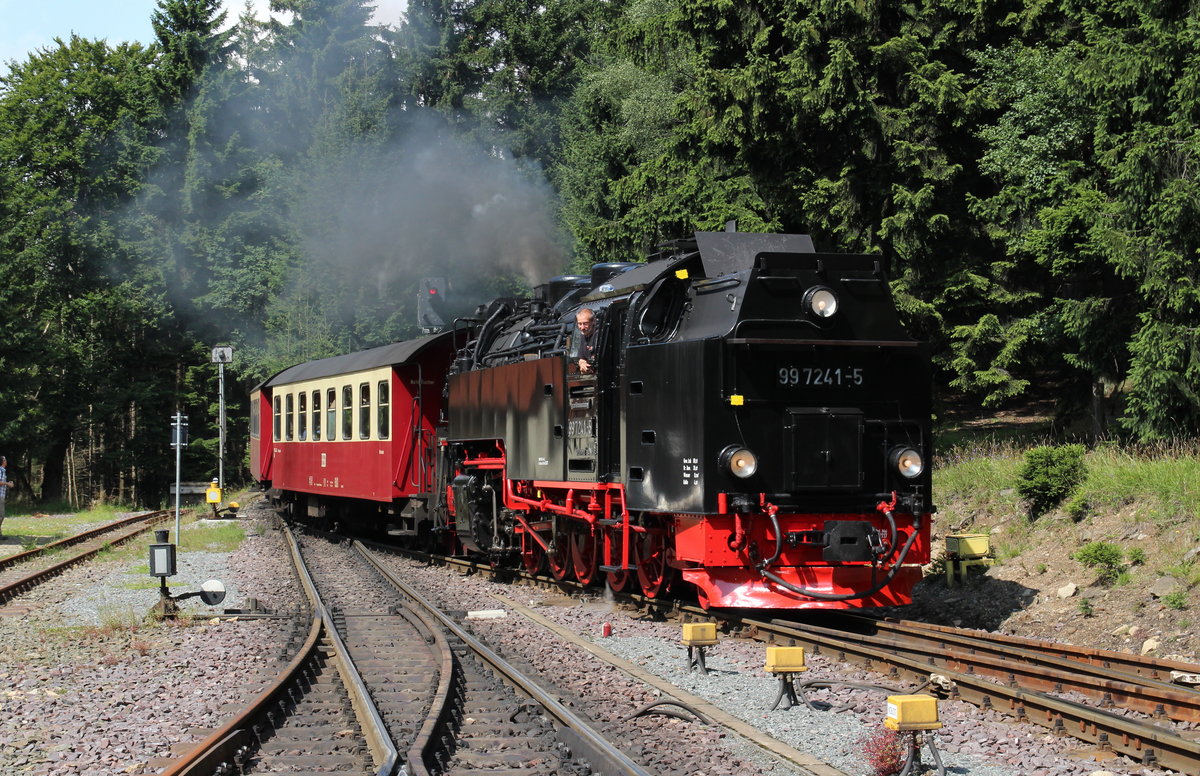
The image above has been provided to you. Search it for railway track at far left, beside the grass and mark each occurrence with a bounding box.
[0,510,174,603]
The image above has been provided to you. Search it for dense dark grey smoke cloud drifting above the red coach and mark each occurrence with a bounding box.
[294,116,566,298]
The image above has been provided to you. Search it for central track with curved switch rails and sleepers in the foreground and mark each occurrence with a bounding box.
[167,527,646,776]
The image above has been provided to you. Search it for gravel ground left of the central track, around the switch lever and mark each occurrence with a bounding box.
[0,503,298,776]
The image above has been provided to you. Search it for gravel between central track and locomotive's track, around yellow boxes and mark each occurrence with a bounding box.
[379,551,1185,776]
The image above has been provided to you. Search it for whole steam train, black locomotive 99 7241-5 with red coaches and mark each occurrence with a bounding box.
[251,231,934,609]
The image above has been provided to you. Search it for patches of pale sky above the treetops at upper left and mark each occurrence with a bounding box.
[0,0,406,72]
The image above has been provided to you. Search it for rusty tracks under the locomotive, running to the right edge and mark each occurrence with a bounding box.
[396,546,1200,776]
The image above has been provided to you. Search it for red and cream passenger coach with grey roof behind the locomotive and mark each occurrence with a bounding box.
[251,332,452,535]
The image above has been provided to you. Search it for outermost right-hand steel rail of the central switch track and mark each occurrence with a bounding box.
[353,541,649,776]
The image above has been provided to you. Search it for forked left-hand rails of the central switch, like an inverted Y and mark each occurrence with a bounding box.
[156,529,397,776]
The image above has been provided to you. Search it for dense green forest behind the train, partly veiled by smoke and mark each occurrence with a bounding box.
[0,0,1200,504]
